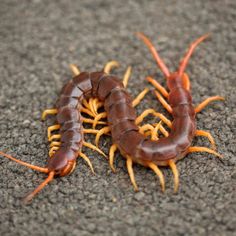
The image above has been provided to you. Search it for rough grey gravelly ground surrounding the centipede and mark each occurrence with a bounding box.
[0,0,236,236]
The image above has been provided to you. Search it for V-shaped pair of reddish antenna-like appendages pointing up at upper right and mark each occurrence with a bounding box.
[136,32,209,78]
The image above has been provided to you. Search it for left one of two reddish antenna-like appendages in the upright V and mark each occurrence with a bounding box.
[136,32,170,78]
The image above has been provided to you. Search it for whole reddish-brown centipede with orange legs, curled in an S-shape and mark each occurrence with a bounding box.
[0,33,224,202]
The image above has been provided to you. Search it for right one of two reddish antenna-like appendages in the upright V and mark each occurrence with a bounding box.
[178,34,210,77]
